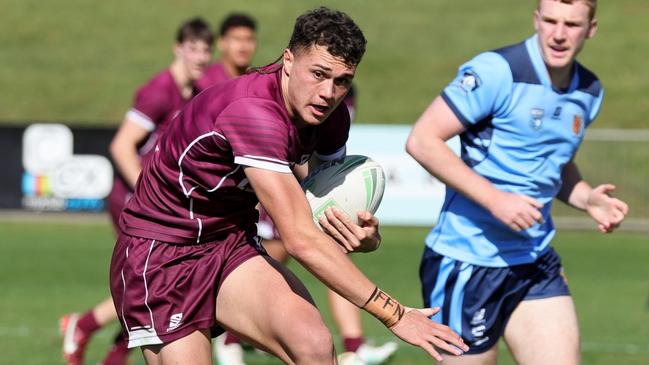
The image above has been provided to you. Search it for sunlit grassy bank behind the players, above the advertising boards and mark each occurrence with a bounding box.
[0,0,649,128]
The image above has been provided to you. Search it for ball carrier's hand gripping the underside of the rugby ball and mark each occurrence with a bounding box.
[320,207,381,252]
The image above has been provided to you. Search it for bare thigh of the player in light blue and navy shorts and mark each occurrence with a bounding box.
[505,295,580,365]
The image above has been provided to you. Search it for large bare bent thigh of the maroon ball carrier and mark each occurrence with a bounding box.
[216,256,333,360]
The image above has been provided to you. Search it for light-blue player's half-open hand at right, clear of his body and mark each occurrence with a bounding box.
[586,184,629,233]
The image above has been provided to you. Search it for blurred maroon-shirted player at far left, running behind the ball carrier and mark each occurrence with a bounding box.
[61,18,214,365]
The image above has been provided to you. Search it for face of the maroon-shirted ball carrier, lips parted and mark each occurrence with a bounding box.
[282,46,356,125]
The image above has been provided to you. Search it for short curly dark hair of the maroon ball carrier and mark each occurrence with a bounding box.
[288,6,367,66]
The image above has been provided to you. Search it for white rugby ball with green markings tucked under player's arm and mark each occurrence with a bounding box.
[302,155,385,226]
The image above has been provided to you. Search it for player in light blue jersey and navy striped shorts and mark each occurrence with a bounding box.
[407,0,628,365]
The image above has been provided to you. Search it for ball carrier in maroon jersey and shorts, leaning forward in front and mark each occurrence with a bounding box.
[110,8,468,365]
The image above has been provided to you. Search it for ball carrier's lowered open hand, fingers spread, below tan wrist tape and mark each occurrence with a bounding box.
[390,307,469,361]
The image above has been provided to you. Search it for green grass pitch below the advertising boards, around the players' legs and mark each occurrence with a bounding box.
[0,222,649,365]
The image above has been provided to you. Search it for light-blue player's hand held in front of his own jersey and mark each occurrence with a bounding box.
[486,191,543,232]
